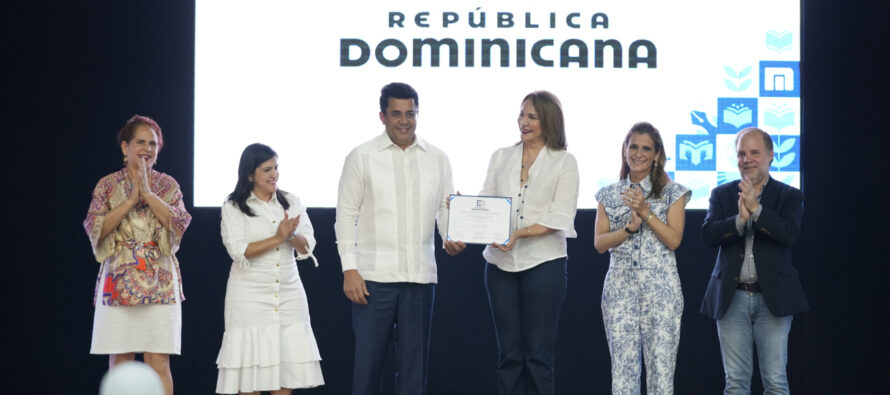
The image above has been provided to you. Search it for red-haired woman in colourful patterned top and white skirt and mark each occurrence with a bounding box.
[83,115,192,395]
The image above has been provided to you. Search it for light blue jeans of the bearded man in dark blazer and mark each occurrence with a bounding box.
[717,290,793,394]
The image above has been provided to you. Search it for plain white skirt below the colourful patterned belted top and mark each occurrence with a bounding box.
[90,264,182,355]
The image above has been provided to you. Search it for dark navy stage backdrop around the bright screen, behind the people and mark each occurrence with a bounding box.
[0,1,890,394]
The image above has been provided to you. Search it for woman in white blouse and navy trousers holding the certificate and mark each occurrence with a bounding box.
[479,91,578,394]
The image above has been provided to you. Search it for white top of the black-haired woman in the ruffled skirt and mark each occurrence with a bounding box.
[220,192,318,270]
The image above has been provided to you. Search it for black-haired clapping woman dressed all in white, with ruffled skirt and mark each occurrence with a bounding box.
[216,144,324,395]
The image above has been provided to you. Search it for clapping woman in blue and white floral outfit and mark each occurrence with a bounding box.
[594,122,690,394]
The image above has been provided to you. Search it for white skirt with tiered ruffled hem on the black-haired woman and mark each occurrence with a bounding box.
[216,262,324,394]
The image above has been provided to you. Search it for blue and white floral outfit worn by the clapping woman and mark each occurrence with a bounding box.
[596,176,691,394]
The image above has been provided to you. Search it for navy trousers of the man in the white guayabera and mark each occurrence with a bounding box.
[352,281,436,395]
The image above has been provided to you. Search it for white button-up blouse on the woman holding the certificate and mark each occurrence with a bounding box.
[479,144,578,272]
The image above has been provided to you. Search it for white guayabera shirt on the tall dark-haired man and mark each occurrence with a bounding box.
[334,133,453,284]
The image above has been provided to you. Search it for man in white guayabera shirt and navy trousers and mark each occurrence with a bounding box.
[334,82,466,395]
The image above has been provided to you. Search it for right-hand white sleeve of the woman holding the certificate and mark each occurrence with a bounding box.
[537,152,579,237]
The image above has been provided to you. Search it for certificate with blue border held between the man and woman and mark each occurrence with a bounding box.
[447,195,513,244]
